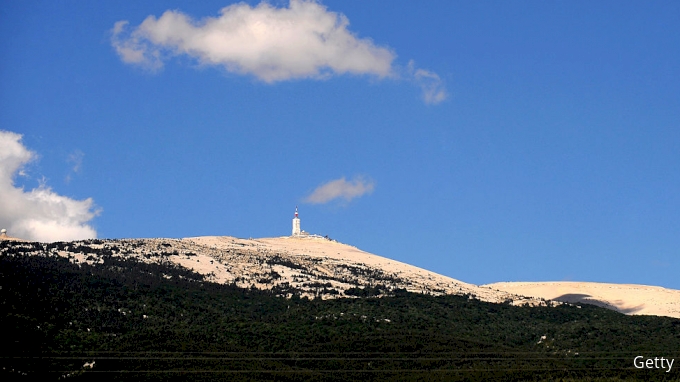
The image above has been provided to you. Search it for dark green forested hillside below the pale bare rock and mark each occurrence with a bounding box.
[0,242,680,381]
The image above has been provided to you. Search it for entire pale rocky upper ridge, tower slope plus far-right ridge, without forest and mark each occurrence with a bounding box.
[5,236,680,318]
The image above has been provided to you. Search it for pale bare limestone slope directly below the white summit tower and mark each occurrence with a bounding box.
[180,236,545,305]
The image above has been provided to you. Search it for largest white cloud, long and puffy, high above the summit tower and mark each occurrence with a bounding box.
[111,0,395,83]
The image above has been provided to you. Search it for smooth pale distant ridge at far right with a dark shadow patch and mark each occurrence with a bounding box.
[482,281,680,318]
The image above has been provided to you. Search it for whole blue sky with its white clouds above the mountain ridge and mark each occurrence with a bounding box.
[0,1,680,289]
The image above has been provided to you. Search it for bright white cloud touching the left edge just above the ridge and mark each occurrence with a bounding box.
[0,130,99,242]
